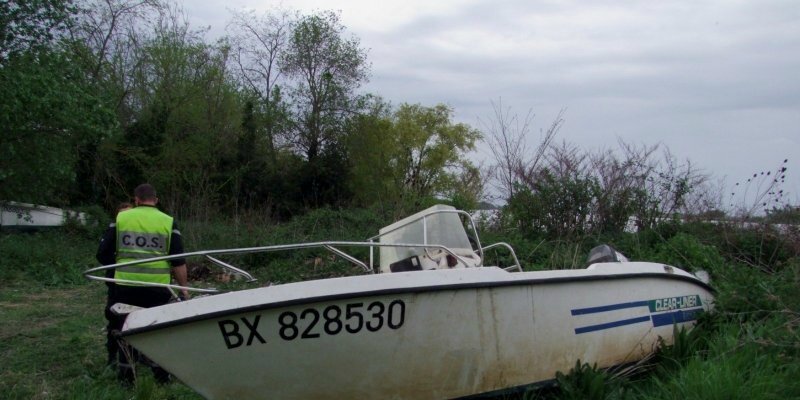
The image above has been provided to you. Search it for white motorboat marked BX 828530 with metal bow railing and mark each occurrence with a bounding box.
[86,206,713,399]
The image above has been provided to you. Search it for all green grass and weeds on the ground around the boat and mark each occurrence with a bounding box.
[0,210,800,400]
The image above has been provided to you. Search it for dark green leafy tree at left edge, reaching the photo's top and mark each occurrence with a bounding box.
[0,1,115,205]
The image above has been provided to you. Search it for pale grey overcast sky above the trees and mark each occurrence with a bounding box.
[184,0,800,209]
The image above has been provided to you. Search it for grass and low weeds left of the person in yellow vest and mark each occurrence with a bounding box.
[0,231,200,399]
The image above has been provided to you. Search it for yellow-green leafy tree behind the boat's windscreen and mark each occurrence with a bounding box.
[346,101,483,215]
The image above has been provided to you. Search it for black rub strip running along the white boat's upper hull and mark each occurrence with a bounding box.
[120,267,716,337]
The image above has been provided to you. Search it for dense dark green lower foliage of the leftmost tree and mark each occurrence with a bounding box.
[0,49,114,205]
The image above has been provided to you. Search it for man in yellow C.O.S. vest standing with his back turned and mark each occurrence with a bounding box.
[97,183,189,383]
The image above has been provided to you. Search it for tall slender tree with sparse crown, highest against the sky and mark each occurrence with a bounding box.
[280,11,369,207]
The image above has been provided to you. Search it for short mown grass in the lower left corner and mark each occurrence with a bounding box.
[0,283,196,399]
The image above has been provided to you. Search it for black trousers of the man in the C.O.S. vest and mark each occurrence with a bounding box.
[105,285,172,382]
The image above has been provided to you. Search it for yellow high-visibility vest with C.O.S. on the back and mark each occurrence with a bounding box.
[114,206,172,285]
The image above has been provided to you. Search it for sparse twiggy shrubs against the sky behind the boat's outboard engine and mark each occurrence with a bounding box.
[495,138,707,244]
